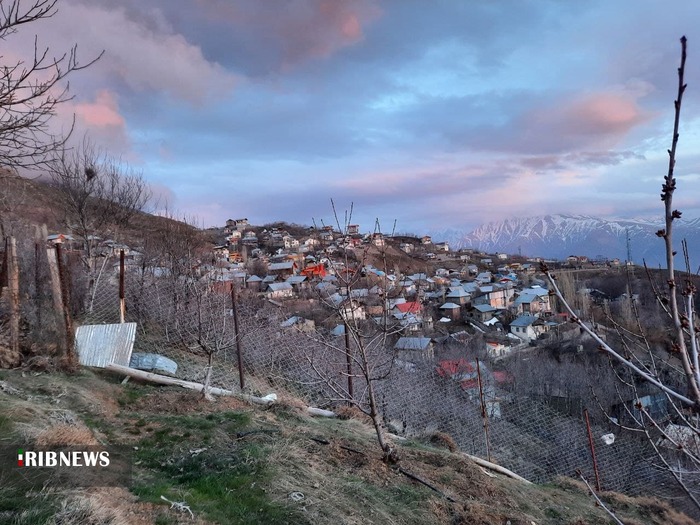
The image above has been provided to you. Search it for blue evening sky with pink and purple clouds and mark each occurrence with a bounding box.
[9,0,700,234]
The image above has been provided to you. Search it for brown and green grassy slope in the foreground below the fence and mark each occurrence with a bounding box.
[0,371,693,525]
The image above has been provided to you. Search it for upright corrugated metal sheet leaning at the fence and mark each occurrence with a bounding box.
[75,323,136,368]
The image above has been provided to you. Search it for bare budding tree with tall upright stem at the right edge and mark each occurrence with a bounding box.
[544,37,700,509]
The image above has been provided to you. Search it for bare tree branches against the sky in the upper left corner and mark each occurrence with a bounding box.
[0,0,102,168]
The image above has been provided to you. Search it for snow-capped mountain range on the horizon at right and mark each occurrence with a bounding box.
[432,215,700,266]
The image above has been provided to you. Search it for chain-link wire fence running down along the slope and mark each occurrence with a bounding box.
[4,246,697,508]
